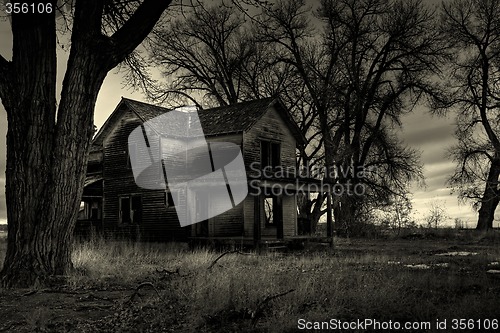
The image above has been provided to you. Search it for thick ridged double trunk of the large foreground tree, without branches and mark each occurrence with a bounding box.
[0,6,107,287]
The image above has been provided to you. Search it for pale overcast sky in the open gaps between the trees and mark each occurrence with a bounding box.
[0,7,497,227]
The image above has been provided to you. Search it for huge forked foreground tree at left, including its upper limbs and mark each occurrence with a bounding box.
[0,0,170,287]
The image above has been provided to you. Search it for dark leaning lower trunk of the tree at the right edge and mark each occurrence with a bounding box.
[476,156,500,230]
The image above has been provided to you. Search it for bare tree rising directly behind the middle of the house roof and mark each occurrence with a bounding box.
[149,3,272,105]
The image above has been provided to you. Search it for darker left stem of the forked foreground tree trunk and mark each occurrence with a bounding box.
[0,6,60,286]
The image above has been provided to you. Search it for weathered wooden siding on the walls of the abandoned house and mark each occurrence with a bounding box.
[93,100,297,241]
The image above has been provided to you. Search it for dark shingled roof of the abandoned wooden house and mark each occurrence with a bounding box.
[94,97,306,149]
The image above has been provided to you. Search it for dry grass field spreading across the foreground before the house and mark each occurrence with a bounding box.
[0,232,500,332]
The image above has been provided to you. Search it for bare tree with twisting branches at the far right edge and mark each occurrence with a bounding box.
[435,0,500,230]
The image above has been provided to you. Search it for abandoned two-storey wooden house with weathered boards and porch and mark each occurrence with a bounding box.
[76,98,305,244]
